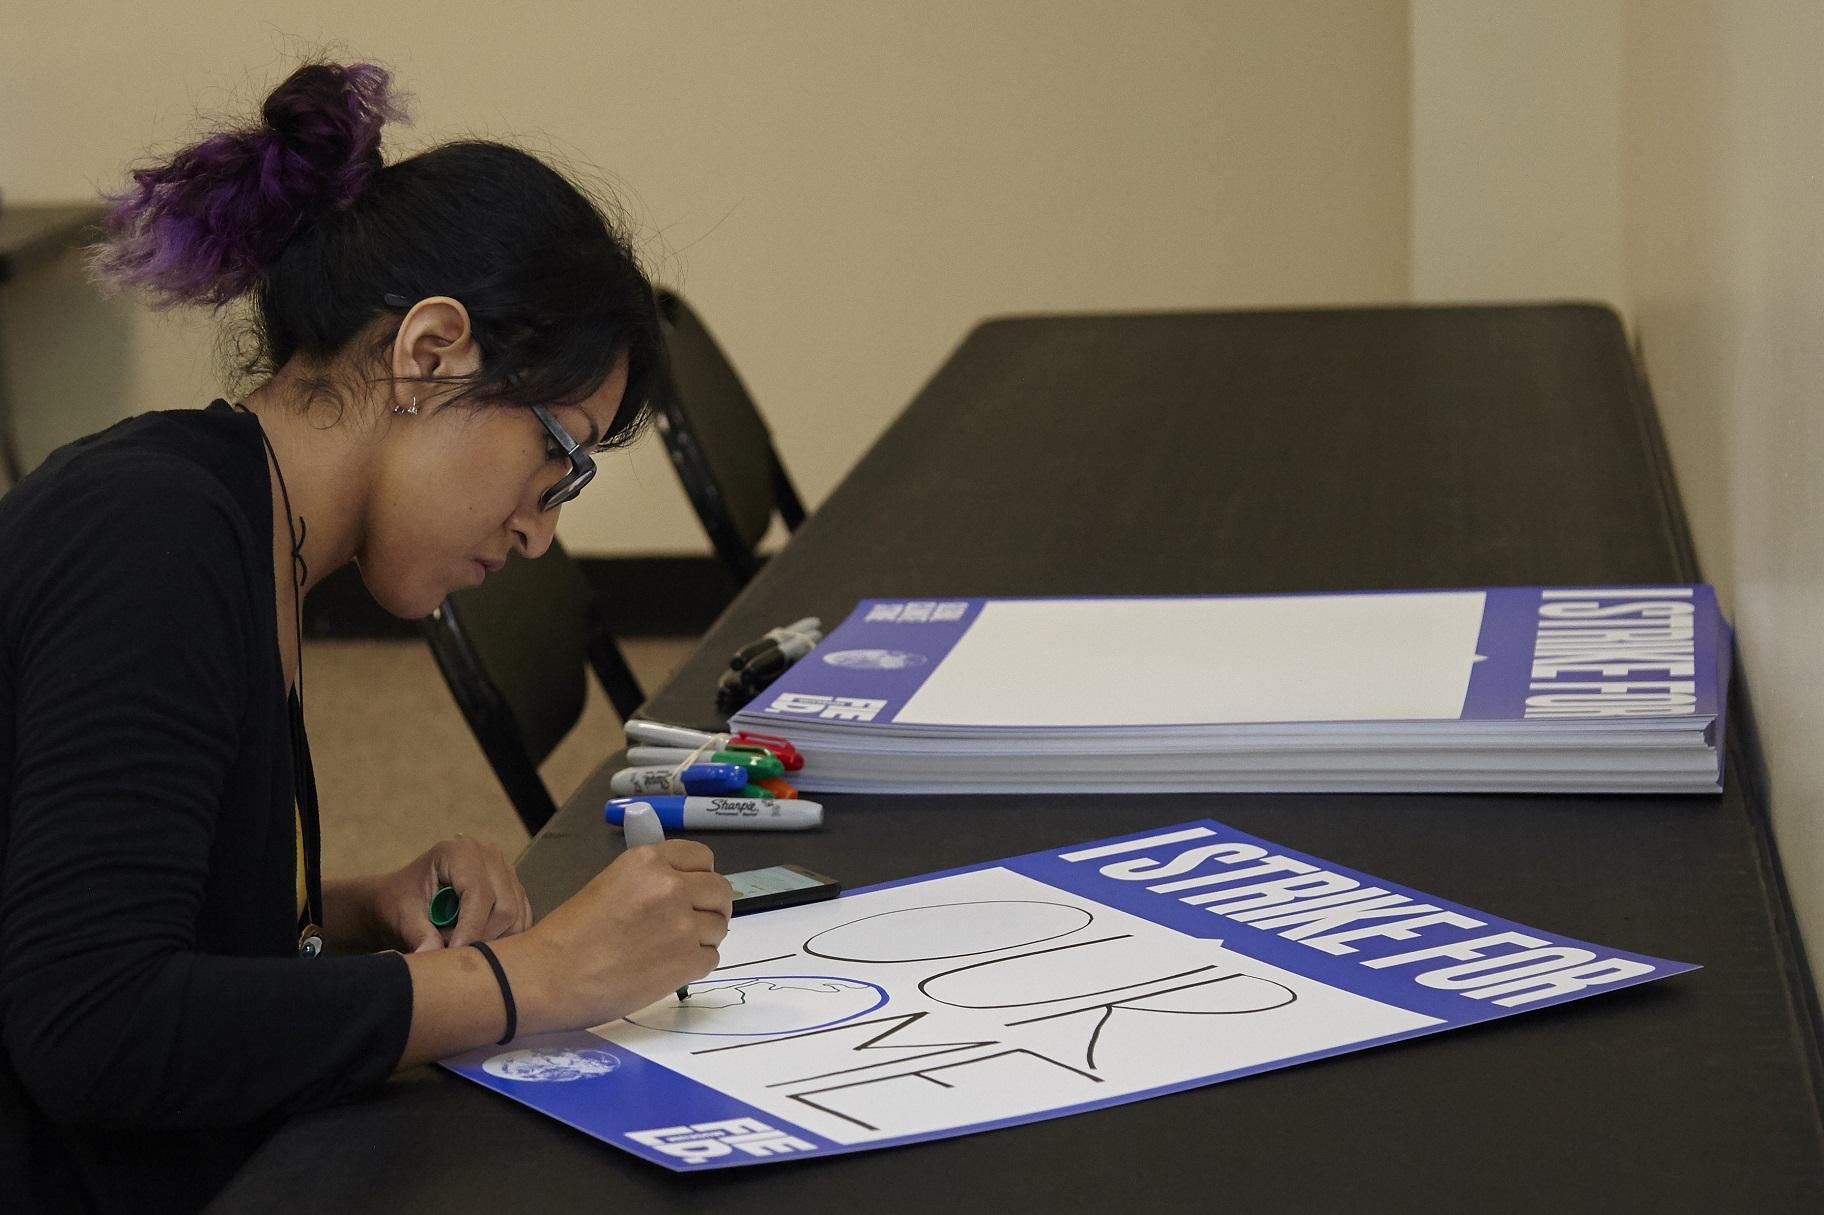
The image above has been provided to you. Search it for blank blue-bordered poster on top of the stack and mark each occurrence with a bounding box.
[733,586,1727,735]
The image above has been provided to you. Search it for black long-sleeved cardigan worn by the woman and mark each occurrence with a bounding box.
[0,401,412,1211]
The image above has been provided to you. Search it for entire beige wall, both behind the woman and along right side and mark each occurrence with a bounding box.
[0,0,1824,971]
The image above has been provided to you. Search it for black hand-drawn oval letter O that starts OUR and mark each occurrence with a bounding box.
[804,899,1094,961]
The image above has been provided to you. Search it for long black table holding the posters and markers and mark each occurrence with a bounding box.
[207,305,1824,1215]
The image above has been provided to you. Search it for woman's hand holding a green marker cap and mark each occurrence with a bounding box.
[372,836,533,954]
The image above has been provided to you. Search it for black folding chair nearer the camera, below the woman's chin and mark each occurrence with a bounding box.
[423,540,646,834]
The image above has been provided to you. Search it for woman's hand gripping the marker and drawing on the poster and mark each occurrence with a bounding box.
[503,839,733,1034]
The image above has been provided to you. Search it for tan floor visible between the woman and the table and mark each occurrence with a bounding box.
[305,637,697,878]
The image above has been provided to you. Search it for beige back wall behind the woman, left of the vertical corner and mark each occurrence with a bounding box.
[0,0,1408,553]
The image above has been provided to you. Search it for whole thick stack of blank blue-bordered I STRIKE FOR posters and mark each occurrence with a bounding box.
[731,586,1731,794]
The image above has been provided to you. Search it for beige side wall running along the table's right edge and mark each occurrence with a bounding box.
[1623,0,1824,976]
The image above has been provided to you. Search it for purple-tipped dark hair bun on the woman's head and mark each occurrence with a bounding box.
[91,64,403,306]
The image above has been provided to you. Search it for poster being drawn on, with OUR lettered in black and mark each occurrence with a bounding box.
[443,819,1694,1171]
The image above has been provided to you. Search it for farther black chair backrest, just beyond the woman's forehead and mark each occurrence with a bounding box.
[655,290,804,582]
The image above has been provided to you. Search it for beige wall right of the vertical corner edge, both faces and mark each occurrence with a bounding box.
[1412,0,1824,974]
